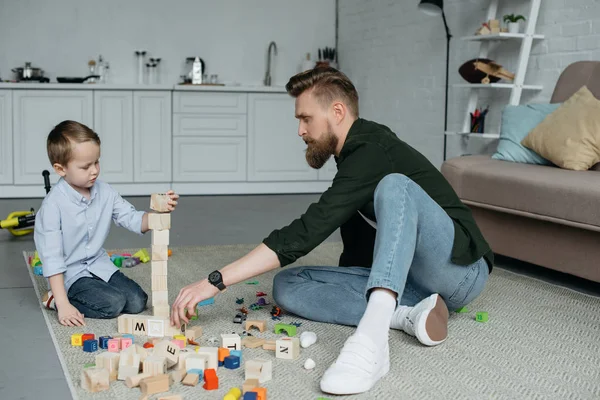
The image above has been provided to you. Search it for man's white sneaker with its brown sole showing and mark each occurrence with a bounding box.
[390,293,448,346]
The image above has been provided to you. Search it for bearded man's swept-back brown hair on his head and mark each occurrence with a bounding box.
[285,67,358,118]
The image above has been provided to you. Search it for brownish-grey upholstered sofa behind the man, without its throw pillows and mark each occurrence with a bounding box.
[441,61,600,282]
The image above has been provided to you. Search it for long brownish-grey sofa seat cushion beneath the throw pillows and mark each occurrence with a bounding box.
[442,156,600,228]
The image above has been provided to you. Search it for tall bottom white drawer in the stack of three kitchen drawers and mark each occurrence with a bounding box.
[173,137,246,182]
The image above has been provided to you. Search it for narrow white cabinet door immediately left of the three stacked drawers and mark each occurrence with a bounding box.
[133,91,172,182]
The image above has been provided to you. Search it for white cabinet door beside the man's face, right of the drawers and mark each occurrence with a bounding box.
[248,93,318,181]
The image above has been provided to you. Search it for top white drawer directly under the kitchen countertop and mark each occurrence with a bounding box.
[173,92,248,114]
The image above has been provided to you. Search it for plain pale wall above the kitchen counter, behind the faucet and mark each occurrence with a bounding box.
[0,0,335,85]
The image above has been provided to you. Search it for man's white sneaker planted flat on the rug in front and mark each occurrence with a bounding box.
[321,333,390,394]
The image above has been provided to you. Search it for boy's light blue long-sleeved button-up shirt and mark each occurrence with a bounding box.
[34,178,144,292]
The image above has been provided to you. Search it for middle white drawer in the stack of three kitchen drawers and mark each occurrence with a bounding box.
[173,114,247,137]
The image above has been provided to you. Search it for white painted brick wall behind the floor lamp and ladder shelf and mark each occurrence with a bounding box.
[338,0,600,166]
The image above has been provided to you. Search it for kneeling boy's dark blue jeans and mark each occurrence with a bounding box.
[67,271,148,319]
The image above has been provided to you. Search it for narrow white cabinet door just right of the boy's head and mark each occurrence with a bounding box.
[94,90,133,183]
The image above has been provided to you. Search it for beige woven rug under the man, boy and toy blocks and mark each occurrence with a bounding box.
[24,243,600,400]
